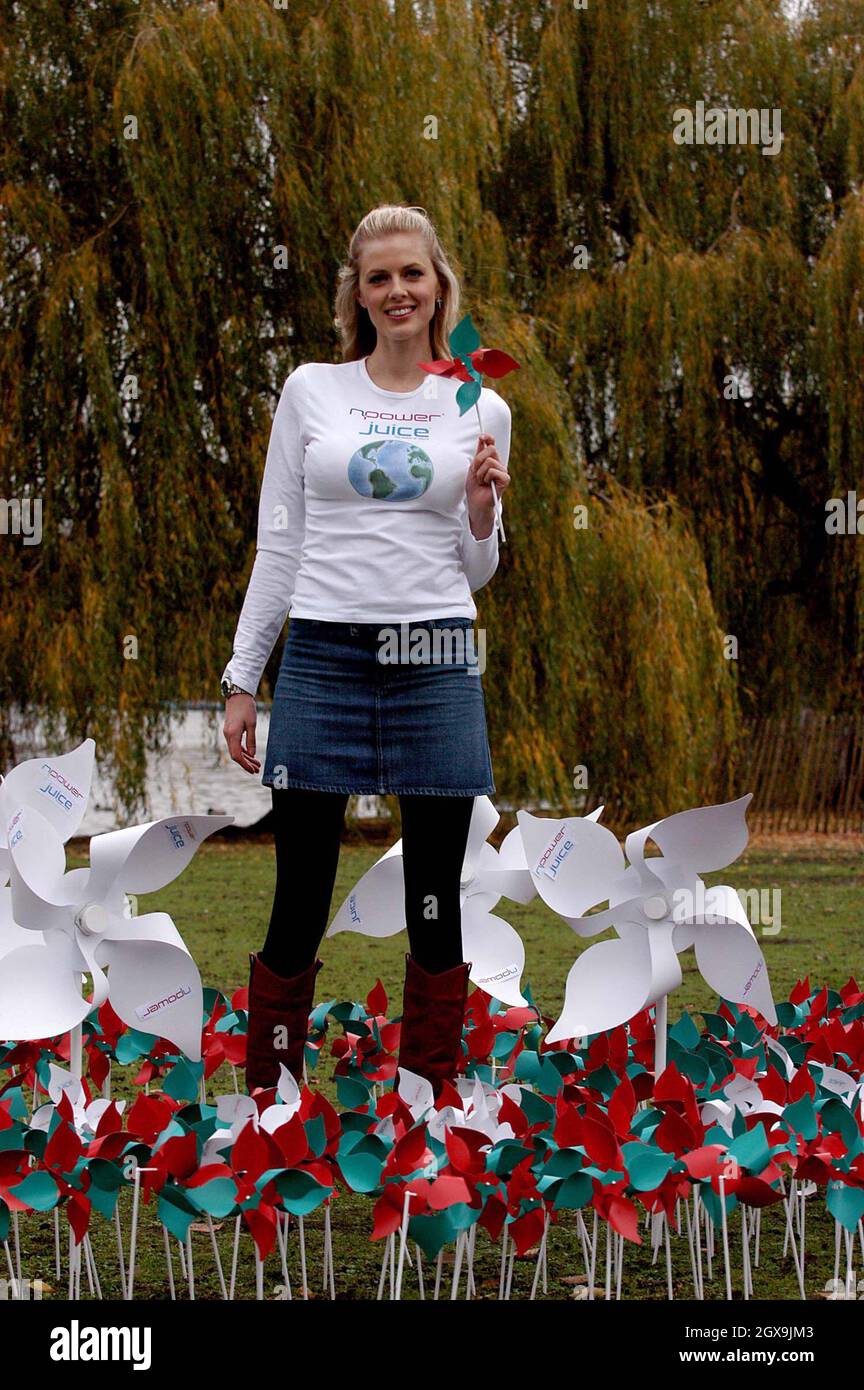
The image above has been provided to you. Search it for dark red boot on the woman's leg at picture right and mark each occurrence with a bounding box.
[394,951,471,1099]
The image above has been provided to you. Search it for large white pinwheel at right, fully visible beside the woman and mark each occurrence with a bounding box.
[517,792,776,1043]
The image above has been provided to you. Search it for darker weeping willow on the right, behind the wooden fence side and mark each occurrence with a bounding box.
[497,0,864,713]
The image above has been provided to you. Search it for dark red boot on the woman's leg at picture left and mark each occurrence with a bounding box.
[246,951,324,1094]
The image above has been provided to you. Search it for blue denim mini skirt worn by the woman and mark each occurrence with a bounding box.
[261,617,495,796]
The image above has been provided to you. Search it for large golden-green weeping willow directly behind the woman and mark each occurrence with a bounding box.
[0,0,755,819]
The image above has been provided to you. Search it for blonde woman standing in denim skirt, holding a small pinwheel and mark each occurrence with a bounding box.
[222,206,510,1098]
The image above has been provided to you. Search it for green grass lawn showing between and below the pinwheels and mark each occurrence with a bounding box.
[22,840,864,1300]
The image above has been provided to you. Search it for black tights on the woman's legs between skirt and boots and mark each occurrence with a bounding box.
[261,787,474,976]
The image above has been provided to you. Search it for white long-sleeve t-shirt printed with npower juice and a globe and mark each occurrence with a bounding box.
[224,359,510,695]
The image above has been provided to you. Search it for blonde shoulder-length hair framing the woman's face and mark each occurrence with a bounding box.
[333,203,460,361]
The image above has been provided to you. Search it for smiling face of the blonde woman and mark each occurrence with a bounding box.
[357,232,440,350]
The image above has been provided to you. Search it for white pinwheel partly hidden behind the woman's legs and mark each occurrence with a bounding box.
[328,796,538,1006]
